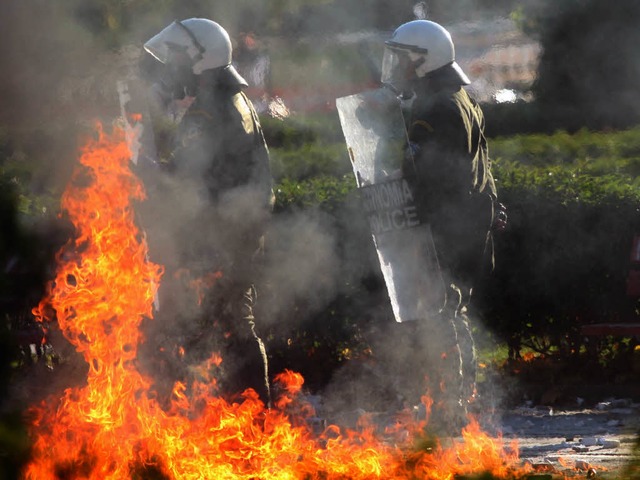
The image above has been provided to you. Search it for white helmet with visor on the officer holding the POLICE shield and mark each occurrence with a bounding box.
[380,20,471,86]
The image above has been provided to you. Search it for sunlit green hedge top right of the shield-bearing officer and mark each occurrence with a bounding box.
[491,128,640,205]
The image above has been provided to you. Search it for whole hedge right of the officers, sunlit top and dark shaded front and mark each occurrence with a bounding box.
[476,127,640,360]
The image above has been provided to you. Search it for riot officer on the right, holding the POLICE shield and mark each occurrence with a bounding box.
[381,20,497,432]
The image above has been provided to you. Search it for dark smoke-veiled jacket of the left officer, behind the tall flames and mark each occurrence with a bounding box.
[169,81,274,276]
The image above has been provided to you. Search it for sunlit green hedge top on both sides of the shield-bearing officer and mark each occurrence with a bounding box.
[264,115,640,213]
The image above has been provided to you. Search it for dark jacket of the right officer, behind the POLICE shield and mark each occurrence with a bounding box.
[404,71,497,287]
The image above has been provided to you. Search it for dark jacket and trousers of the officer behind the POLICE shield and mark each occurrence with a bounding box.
[403,68,497,425]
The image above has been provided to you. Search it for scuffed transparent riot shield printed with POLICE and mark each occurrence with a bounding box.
[336,88,446,322]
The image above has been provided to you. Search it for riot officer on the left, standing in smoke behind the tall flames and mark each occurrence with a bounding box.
[144,18,274,402]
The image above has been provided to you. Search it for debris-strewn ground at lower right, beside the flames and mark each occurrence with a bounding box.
[473,359,640,479]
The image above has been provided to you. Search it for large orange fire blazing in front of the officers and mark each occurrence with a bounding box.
[24,124,527,480]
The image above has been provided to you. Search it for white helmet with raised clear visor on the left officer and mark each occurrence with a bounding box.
[144,18,246,84]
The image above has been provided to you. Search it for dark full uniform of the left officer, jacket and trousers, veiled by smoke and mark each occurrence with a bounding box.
[167,78,274,401]
